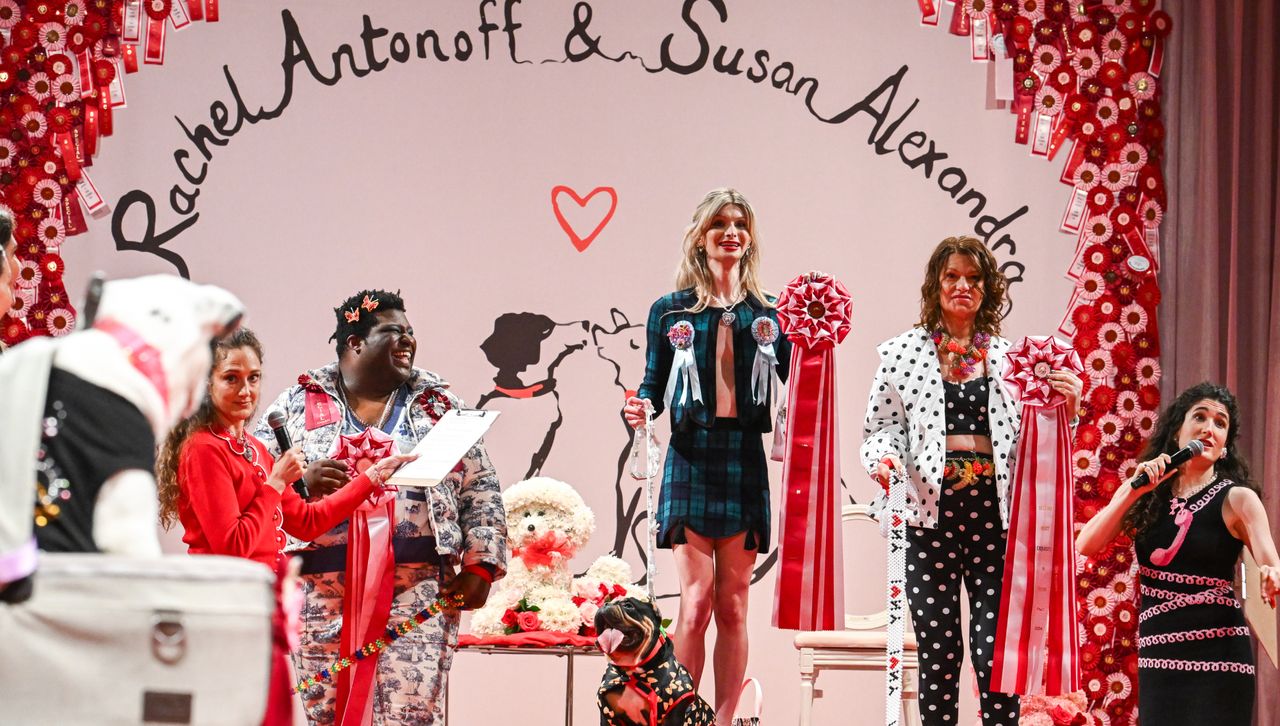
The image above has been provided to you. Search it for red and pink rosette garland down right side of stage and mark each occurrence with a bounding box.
[918,0,1174,723]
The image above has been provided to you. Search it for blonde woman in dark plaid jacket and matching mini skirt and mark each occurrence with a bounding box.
[623,188,791,726]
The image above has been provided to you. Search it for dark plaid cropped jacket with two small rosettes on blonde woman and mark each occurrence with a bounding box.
[637,288,791,433]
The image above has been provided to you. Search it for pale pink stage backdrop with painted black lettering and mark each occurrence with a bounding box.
[64,0,1074,723]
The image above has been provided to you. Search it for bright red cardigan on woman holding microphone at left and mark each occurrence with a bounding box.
[178,428,375,569]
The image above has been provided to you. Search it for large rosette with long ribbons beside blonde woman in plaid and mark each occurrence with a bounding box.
[773,273,852,630]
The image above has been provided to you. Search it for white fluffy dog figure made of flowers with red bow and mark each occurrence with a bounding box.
[471,476,631,635]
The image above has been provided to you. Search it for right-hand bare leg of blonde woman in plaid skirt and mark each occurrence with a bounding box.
[713,533,756,726]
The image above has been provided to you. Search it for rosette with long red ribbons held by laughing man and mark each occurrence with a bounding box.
[330,428,396,723]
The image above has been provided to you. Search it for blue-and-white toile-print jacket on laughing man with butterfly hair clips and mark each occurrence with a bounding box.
[253,364,507,576]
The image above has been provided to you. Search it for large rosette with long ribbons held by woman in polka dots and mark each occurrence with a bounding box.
[991,335,1084,695]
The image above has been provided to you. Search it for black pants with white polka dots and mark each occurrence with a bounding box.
[906,478,1018,726]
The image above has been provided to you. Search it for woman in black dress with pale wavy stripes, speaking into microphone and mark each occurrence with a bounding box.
[1076,383,1280,726]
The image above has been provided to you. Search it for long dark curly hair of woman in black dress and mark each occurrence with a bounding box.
[1123,380,1262,536]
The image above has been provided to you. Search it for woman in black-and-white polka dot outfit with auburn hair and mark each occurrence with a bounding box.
[861,237,1083,726]
